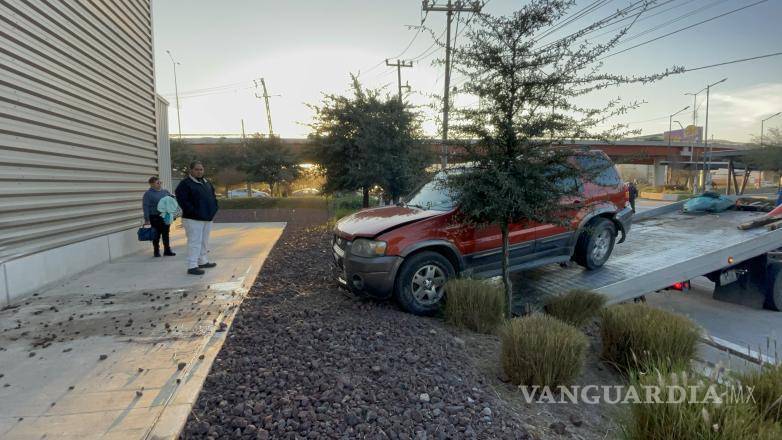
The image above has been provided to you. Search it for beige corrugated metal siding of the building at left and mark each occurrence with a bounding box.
[0,0,158,262]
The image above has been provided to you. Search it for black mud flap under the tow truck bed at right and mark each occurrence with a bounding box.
[707,255,768,309]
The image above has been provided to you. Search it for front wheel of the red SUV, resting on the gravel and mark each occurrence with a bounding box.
[394,251,456,316]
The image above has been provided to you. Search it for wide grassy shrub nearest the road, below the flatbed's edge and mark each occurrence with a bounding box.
[600,304,700,371]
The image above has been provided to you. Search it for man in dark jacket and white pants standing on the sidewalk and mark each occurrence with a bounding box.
[176,162,217,275]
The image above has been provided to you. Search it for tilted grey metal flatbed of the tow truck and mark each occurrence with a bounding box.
[512,210,782,311]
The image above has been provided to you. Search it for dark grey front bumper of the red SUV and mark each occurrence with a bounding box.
[332,239,402,298]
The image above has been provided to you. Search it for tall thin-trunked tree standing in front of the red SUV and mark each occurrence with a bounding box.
[446,0,680,316]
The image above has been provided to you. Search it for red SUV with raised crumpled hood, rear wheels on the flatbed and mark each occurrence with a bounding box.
[332,151,633,315]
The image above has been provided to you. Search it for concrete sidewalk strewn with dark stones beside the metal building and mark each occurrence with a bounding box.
[0,223,284,439]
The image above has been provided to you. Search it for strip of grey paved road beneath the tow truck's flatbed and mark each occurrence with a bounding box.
[647,278,782,366]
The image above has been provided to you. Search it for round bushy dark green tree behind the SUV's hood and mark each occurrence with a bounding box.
[311,76,431,208]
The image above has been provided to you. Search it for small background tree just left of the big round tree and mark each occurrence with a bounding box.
[238,136,301,195]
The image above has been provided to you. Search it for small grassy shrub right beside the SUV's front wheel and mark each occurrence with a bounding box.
[445,279,505,333]
